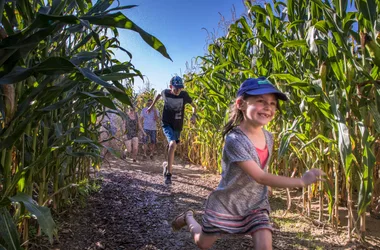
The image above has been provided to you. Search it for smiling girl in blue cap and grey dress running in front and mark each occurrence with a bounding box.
[172,77,324,249]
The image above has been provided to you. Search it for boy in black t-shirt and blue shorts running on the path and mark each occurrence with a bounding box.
[147,76,196,184]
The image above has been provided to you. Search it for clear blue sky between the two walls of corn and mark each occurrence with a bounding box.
[116,0,245,91]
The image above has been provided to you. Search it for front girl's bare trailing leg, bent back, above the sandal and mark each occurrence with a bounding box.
[186,213,218,249]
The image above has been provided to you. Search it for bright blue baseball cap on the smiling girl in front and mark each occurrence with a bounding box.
[237,76,288,101]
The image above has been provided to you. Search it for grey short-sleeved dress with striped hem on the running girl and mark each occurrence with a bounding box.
[202,127,273,236]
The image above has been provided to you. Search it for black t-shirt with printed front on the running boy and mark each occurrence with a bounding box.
[161,89,193,131]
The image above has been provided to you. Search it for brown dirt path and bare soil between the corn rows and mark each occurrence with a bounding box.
[30,152,380,250]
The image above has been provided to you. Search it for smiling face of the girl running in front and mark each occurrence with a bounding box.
[240,94,277,127]
